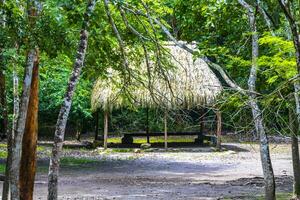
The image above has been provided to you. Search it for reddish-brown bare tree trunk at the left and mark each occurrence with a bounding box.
[20,50,39,200]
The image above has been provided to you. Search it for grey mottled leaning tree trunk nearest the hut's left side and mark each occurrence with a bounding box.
[48,0,96,200]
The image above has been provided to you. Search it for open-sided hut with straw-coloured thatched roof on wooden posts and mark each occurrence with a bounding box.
[91,42,222,148]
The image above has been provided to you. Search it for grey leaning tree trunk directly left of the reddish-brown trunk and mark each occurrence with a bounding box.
[10,49,36,199]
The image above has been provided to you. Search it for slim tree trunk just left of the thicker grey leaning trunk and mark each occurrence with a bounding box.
[2,57,19,200]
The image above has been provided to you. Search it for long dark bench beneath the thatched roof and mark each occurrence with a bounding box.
[122,132,217,146]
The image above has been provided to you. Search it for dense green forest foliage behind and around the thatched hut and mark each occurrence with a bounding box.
[1,0,296,139]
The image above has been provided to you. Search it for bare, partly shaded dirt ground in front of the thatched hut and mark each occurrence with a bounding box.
[0,138,292,200]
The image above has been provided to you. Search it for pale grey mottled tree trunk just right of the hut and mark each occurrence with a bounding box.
[239,0,276,200]
